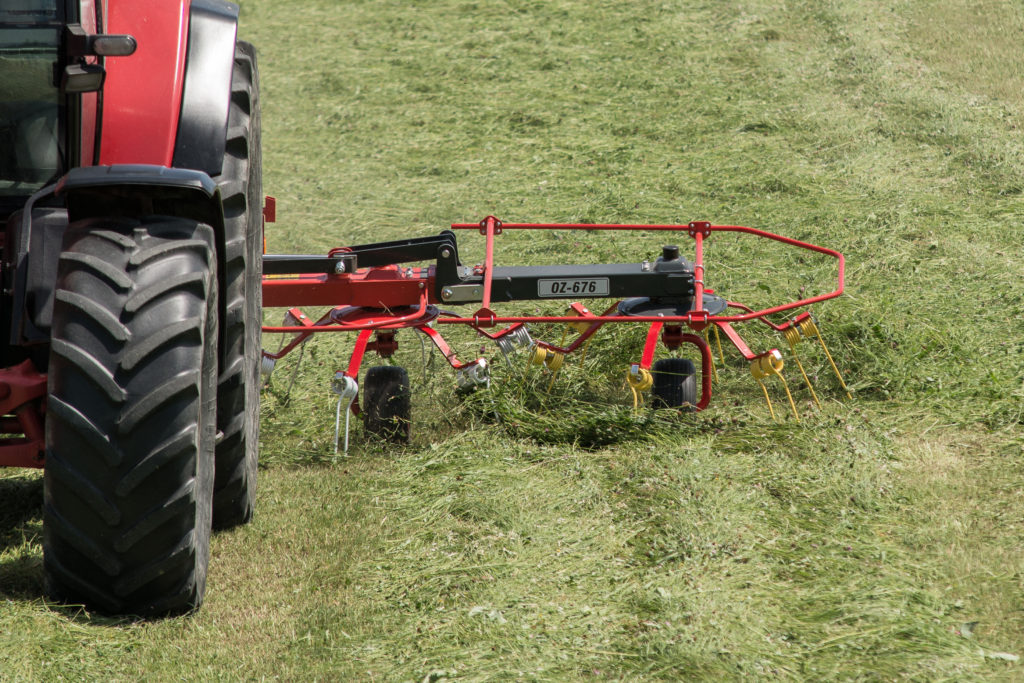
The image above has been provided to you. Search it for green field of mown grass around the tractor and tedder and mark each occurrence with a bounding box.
[0,0,1024,681]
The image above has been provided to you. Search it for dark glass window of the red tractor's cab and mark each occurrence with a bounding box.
[0,0,60,198]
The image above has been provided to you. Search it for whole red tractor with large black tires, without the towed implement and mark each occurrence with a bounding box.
[0,0,262,615]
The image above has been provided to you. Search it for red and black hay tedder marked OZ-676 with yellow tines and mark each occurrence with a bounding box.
[263,216,849,445]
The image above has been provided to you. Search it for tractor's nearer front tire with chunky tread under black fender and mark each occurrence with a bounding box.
[43,216,217,616]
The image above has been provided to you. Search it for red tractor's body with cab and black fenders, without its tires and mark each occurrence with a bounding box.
[0,0,249,479]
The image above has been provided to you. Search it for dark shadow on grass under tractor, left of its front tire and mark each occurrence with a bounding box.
[0,477,43,600]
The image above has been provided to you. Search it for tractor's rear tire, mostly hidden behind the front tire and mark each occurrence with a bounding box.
[213,42,263,528]
